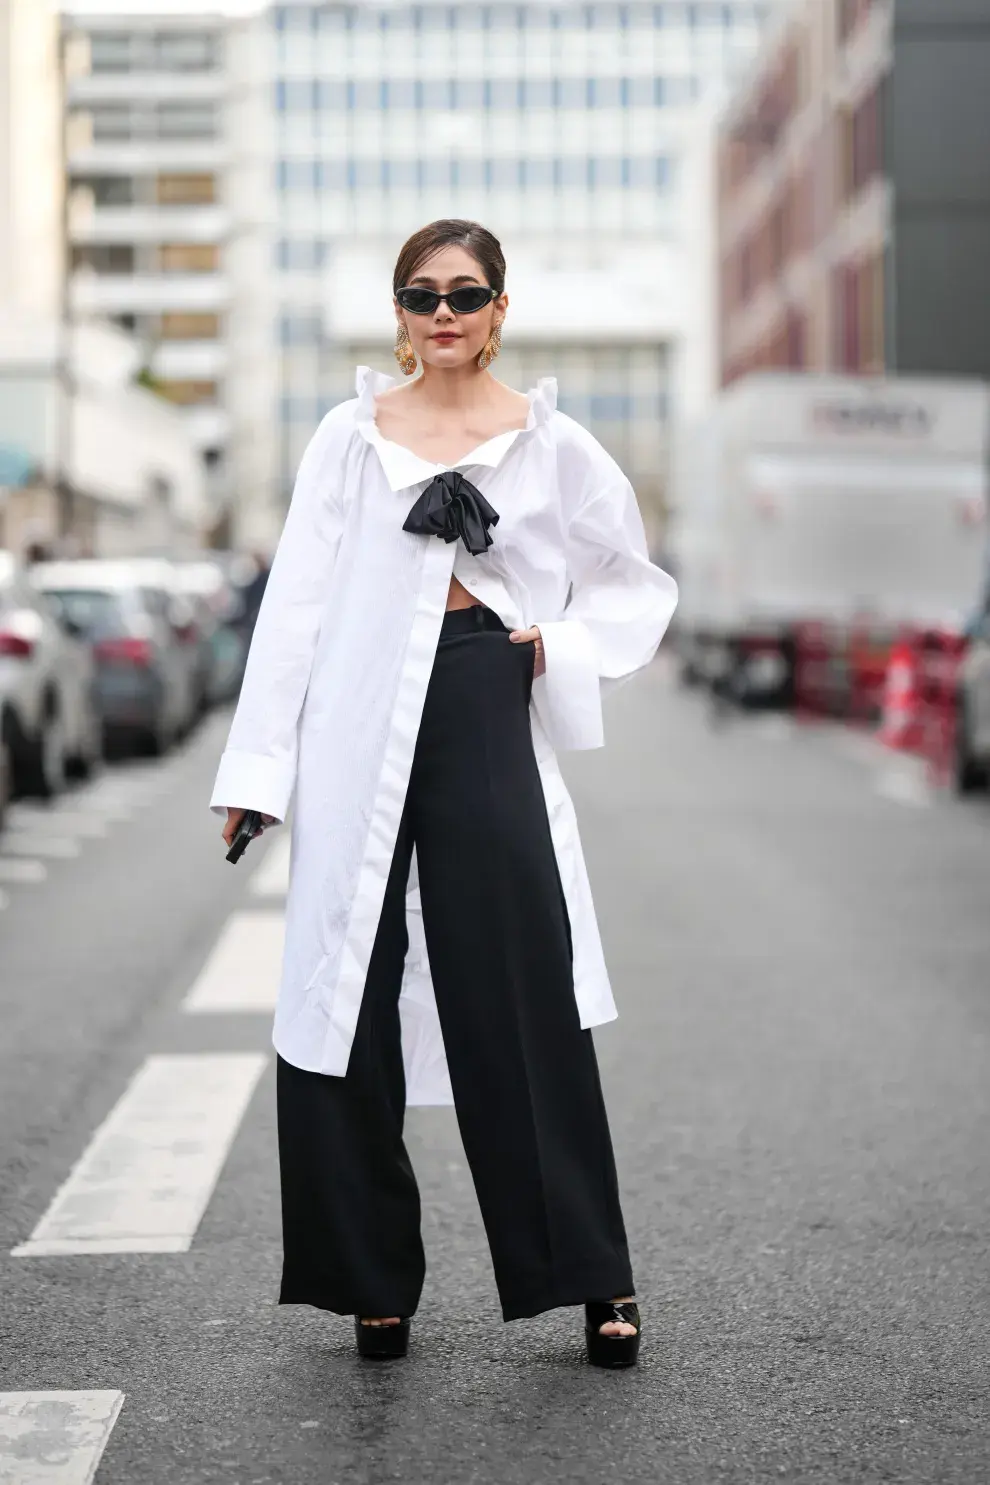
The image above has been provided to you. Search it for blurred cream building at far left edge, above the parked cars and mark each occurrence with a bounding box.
[0,0,205,551]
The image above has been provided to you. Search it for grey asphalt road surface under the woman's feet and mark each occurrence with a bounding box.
[0,665,990,1485]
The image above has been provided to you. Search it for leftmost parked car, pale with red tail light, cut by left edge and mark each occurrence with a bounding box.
[0,551,101,808]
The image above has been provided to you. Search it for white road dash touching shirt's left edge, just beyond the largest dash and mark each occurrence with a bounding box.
[183,912,285,1014]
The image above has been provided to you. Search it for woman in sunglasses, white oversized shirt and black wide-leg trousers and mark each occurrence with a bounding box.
[212,221,675,1366]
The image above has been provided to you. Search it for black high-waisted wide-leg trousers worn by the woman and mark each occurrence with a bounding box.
[278,607,634,1320]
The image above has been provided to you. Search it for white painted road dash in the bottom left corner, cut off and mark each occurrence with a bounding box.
[0,1391,123,1485]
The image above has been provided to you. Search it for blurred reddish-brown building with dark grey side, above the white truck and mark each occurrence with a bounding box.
[718,0,990,382]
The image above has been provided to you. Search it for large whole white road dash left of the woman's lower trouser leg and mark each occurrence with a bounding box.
[12,1053,267,1258]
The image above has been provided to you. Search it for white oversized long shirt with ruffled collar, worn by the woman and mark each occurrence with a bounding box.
[211,367,677,1103]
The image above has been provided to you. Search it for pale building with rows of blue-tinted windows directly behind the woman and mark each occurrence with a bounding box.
[270,0,772,546]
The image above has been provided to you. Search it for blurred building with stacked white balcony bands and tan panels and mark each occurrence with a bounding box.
[65,4,275,545]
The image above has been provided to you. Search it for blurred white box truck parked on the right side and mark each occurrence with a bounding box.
[668,373,990,704]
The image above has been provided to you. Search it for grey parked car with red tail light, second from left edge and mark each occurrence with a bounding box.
[31,558,196,753]
